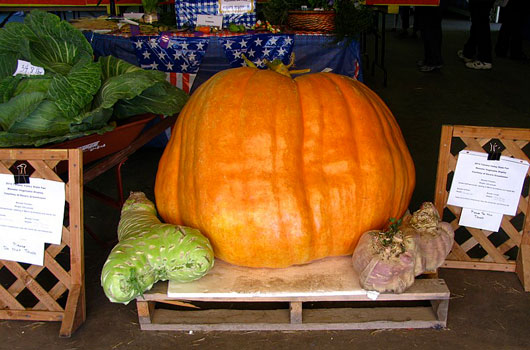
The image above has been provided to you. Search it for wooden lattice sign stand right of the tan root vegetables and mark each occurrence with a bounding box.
[435,125,530,291]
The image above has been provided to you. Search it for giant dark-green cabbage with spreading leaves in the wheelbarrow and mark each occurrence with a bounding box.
[0,10,188,147]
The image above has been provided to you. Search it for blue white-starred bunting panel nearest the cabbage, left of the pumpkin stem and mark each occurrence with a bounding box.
[131,35,209,74]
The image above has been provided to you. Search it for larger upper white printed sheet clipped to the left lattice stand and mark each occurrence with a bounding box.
[0,174,65,244]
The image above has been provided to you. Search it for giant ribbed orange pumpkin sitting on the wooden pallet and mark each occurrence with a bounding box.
[155,63,415,267]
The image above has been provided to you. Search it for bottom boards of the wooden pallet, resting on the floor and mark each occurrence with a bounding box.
[140,306,446,331]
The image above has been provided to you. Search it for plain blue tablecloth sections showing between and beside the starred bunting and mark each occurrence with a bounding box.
[85,32,362,91]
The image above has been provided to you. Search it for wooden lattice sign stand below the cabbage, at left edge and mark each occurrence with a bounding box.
[0,149,86,337]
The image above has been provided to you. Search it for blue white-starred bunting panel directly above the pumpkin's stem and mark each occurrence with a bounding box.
[219,34,294,68]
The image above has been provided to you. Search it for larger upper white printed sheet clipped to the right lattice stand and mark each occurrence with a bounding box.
[447,151,528,216]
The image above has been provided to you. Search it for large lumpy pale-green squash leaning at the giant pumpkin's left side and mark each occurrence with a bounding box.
[101,192,214,304]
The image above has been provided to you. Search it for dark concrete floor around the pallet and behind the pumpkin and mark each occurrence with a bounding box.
[0,15,530,350]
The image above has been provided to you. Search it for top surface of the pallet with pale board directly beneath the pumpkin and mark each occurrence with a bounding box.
[160,256,448,302]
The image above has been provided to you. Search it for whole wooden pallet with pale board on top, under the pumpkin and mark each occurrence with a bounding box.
[137,256,450,331]
